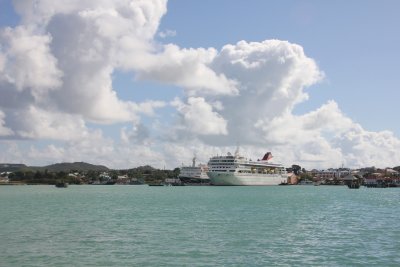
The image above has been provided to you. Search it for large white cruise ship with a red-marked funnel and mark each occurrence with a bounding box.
[207,150,287,185]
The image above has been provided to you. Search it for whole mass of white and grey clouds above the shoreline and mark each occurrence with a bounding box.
[0,0,400,168]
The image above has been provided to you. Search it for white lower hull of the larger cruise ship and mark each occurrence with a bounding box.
[207,172,287,185]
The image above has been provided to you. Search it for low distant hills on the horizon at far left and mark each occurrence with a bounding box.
[0,162,108,172]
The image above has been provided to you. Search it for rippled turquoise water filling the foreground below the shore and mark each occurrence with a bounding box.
[0,185,400,266]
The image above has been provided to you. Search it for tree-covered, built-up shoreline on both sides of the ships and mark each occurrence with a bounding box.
[0,162,400,187]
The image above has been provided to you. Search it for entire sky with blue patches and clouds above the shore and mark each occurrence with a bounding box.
[0,0,400,169]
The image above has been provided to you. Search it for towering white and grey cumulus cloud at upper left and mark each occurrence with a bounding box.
[0,0,170,140]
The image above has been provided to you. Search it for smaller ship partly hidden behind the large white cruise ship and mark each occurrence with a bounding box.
[178,157,210,185]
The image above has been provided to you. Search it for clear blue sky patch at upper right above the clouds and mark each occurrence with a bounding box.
[160,0,400,134]
